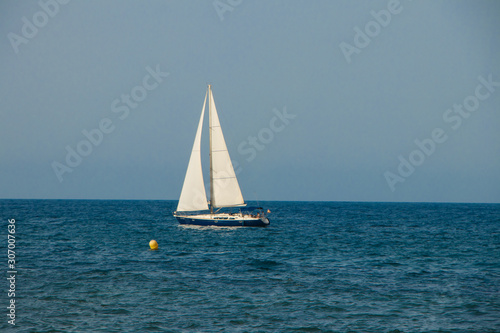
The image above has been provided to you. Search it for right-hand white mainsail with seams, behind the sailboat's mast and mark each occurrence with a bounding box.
[208,85,245,207]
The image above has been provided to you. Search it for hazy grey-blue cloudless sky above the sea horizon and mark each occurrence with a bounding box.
[0,0,500,203]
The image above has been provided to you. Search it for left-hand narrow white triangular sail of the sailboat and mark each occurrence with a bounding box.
[177,94,208,212]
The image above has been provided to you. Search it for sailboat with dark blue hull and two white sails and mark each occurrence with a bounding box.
[173,84,270,227]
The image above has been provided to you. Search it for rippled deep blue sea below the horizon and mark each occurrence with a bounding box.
[0,200,500,333]
